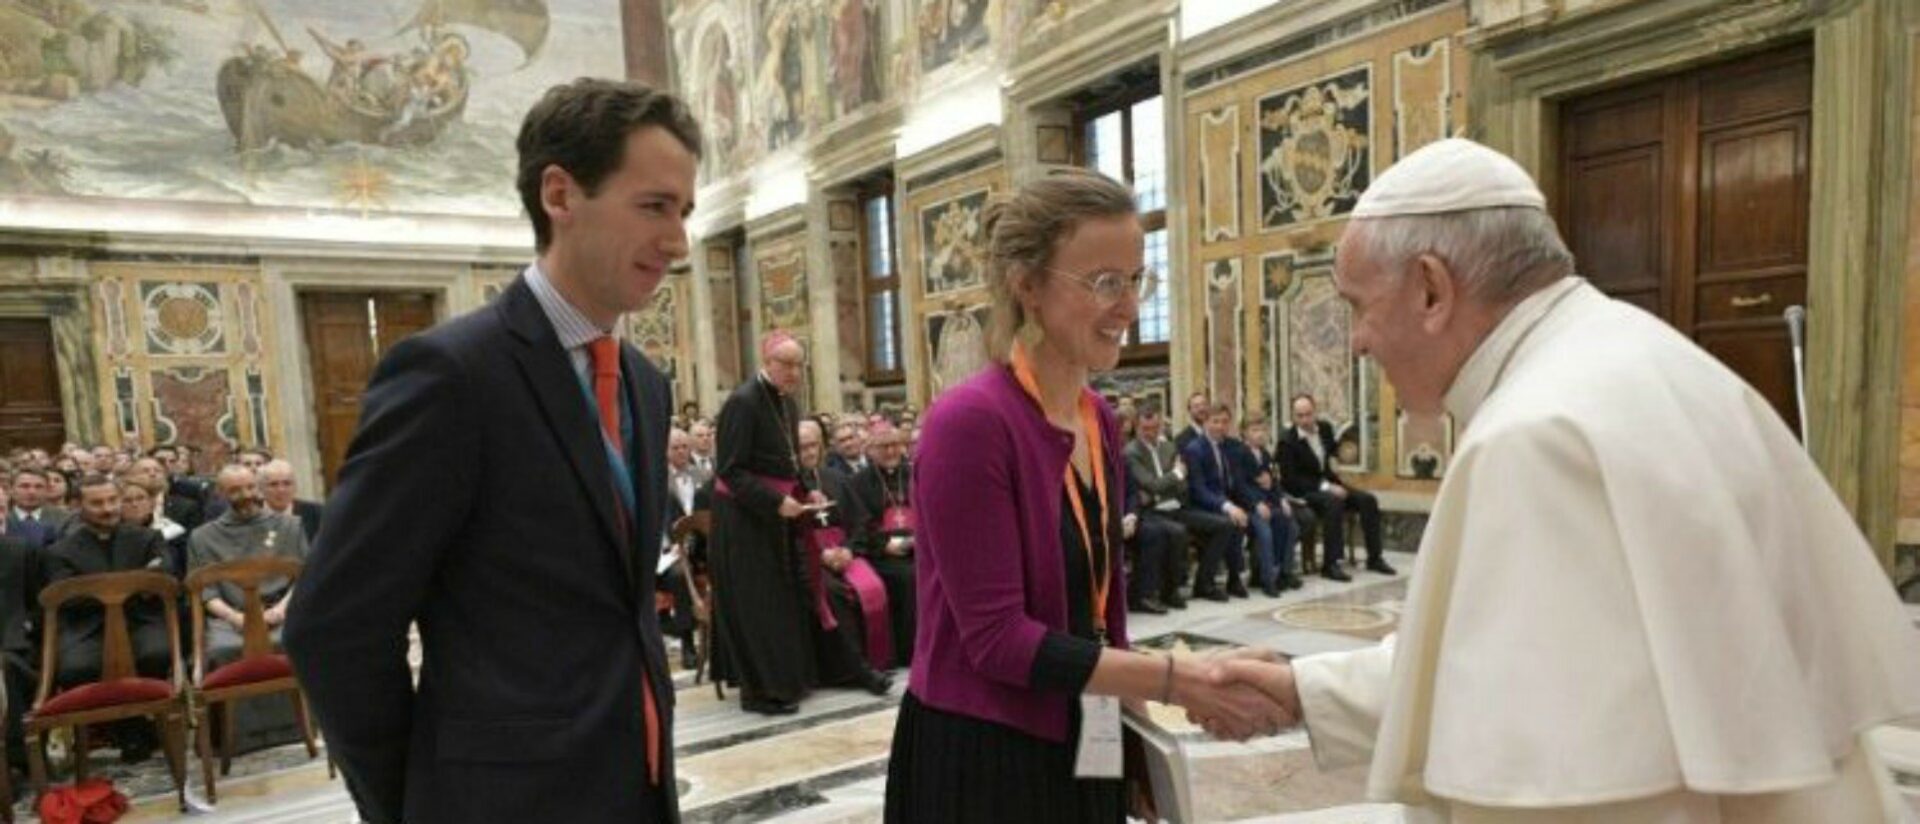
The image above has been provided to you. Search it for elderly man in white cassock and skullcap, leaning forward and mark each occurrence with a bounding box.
[1219,140,1920,824]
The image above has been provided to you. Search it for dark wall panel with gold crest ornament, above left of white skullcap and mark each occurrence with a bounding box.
[1260,63,1373,230]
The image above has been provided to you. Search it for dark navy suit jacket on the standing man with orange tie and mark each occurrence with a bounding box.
[286,280,680,824]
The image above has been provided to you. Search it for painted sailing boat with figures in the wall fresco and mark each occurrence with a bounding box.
[217,0,551,150]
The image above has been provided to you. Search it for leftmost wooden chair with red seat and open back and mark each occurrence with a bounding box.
[25,570,188,812]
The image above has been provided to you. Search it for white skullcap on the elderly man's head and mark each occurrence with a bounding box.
[1354,138,1548,217]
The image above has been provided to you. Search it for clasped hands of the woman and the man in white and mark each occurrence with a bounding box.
[1167,647,1302,741]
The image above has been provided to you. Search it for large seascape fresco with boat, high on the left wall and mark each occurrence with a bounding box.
[0,0,624,217]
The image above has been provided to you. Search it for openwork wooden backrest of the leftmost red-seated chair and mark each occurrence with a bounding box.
[35,570,180,707]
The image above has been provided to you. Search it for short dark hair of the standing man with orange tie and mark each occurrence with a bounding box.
[515,77,701,252]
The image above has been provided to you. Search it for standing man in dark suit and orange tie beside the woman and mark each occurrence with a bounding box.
[286,79,701,824]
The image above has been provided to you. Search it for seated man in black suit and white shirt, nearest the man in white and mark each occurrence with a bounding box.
[1281,394,1394,580]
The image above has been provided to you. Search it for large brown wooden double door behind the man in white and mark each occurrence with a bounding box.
[1555,44,1812,428]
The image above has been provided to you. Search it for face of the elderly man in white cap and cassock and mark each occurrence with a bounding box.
[1334,221,1461,415]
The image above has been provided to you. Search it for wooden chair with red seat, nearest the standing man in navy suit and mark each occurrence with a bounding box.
[186,557,334,803]
